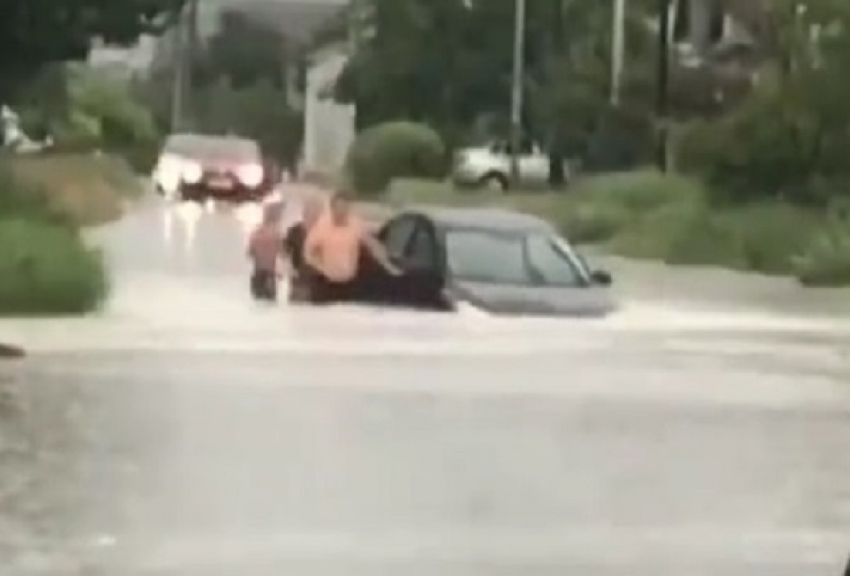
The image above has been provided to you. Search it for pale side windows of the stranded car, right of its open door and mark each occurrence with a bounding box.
[446,230,589,286]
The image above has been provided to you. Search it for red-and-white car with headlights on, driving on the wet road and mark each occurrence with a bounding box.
[153,134,279,202]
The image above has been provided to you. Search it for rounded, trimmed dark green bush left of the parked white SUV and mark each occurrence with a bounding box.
[346,121,446,195]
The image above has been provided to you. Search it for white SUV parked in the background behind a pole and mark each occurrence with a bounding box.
[452,142,568,190]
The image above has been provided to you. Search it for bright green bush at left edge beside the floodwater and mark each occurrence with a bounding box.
[0,217,107,316]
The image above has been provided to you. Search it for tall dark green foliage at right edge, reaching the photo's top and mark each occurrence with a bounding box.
[679,0,850,205]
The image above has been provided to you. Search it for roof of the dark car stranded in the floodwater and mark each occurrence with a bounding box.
[402,206,552,233]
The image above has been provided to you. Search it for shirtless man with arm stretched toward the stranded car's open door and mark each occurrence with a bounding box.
[304,192,402,302]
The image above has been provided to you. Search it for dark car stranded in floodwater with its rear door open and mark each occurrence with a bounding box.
[354,207,616,317]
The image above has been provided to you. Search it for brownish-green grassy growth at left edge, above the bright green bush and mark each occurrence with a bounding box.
[3,154,143,226]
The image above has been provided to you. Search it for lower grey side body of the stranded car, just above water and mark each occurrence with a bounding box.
[449,281,617,317]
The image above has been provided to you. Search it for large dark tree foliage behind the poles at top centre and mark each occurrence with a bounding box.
[321,0,736,158]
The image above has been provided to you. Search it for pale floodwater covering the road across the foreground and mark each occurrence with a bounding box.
[0,191,850,576]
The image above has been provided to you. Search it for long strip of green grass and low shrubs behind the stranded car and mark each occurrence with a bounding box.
[388,170,850,286]
